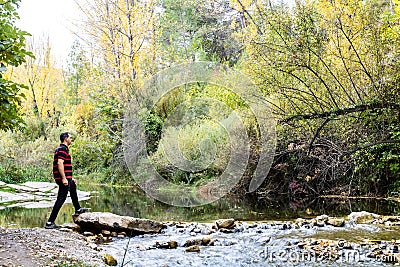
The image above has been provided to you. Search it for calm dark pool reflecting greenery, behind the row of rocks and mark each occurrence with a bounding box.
[0,184,400,227]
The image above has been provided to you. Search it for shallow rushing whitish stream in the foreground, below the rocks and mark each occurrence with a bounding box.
[102,222,400,266]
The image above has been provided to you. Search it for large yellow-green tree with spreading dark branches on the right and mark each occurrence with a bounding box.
[232,0,400,197]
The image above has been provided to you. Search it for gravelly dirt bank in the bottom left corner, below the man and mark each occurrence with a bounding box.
[0,228,105,267]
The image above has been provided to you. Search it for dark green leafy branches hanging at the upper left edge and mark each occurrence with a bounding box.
[0,0,33,130]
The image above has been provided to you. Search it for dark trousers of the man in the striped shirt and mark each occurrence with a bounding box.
[48,179,81,222]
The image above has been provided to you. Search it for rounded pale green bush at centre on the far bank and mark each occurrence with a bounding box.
[151,120,230,184]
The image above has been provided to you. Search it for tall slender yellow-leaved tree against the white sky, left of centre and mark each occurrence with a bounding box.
[77,0,156,100]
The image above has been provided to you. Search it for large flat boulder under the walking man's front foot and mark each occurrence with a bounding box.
[73,212,163,235]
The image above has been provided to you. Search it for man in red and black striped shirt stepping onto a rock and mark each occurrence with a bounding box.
[45,132,88,229]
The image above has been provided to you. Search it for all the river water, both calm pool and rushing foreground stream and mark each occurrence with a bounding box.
[0,185,400,266]
